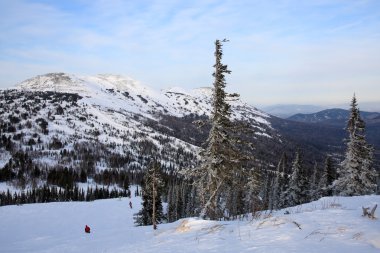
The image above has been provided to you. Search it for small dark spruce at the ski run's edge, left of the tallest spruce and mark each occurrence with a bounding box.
[135,161,164,229]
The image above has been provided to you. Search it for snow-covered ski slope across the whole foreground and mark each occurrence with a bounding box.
[0,191,380,253]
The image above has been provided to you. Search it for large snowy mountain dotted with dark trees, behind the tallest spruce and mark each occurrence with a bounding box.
[0,73,285,191]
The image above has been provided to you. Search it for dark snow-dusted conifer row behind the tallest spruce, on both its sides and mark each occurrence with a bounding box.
[161,151,337,222]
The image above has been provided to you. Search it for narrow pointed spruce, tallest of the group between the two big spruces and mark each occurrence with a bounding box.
[285,151,308,206]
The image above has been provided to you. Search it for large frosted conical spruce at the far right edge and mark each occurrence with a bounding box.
[334,95,377,196]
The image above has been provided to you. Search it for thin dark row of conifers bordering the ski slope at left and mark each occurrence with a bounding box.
[0,185,131,206]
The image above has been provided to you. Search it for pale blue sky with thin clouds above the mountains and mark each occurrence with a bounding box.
[0,0,380,105]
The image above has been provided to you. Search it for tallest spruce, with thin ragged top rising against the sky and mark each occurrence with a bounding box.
[190,39,247,220]
